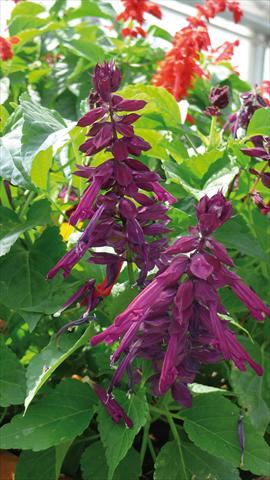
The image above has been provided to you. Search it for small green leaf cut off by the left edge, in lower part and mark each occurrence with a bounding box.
[0,342,25,407]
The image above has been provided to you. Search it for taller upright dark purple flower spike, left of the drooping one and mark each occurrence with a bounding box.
[48,61,175,322]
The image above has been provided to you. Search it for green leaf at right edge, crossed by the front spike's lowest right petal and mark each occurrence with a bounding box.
[231,338,270,435]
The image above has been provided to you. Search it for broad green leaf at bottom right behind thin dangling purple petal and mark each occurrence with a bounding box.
[181,394,270,475]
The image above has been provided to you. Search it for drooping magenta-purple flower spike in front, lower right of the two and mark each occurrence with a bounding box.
[91,193,270,407]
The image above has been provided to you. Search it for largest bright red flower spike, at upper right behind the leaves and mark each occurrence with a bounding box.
[152,0,242,101]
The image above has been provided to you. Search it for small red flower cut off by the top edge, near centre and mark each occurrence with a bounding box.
[116,0,162,37]
